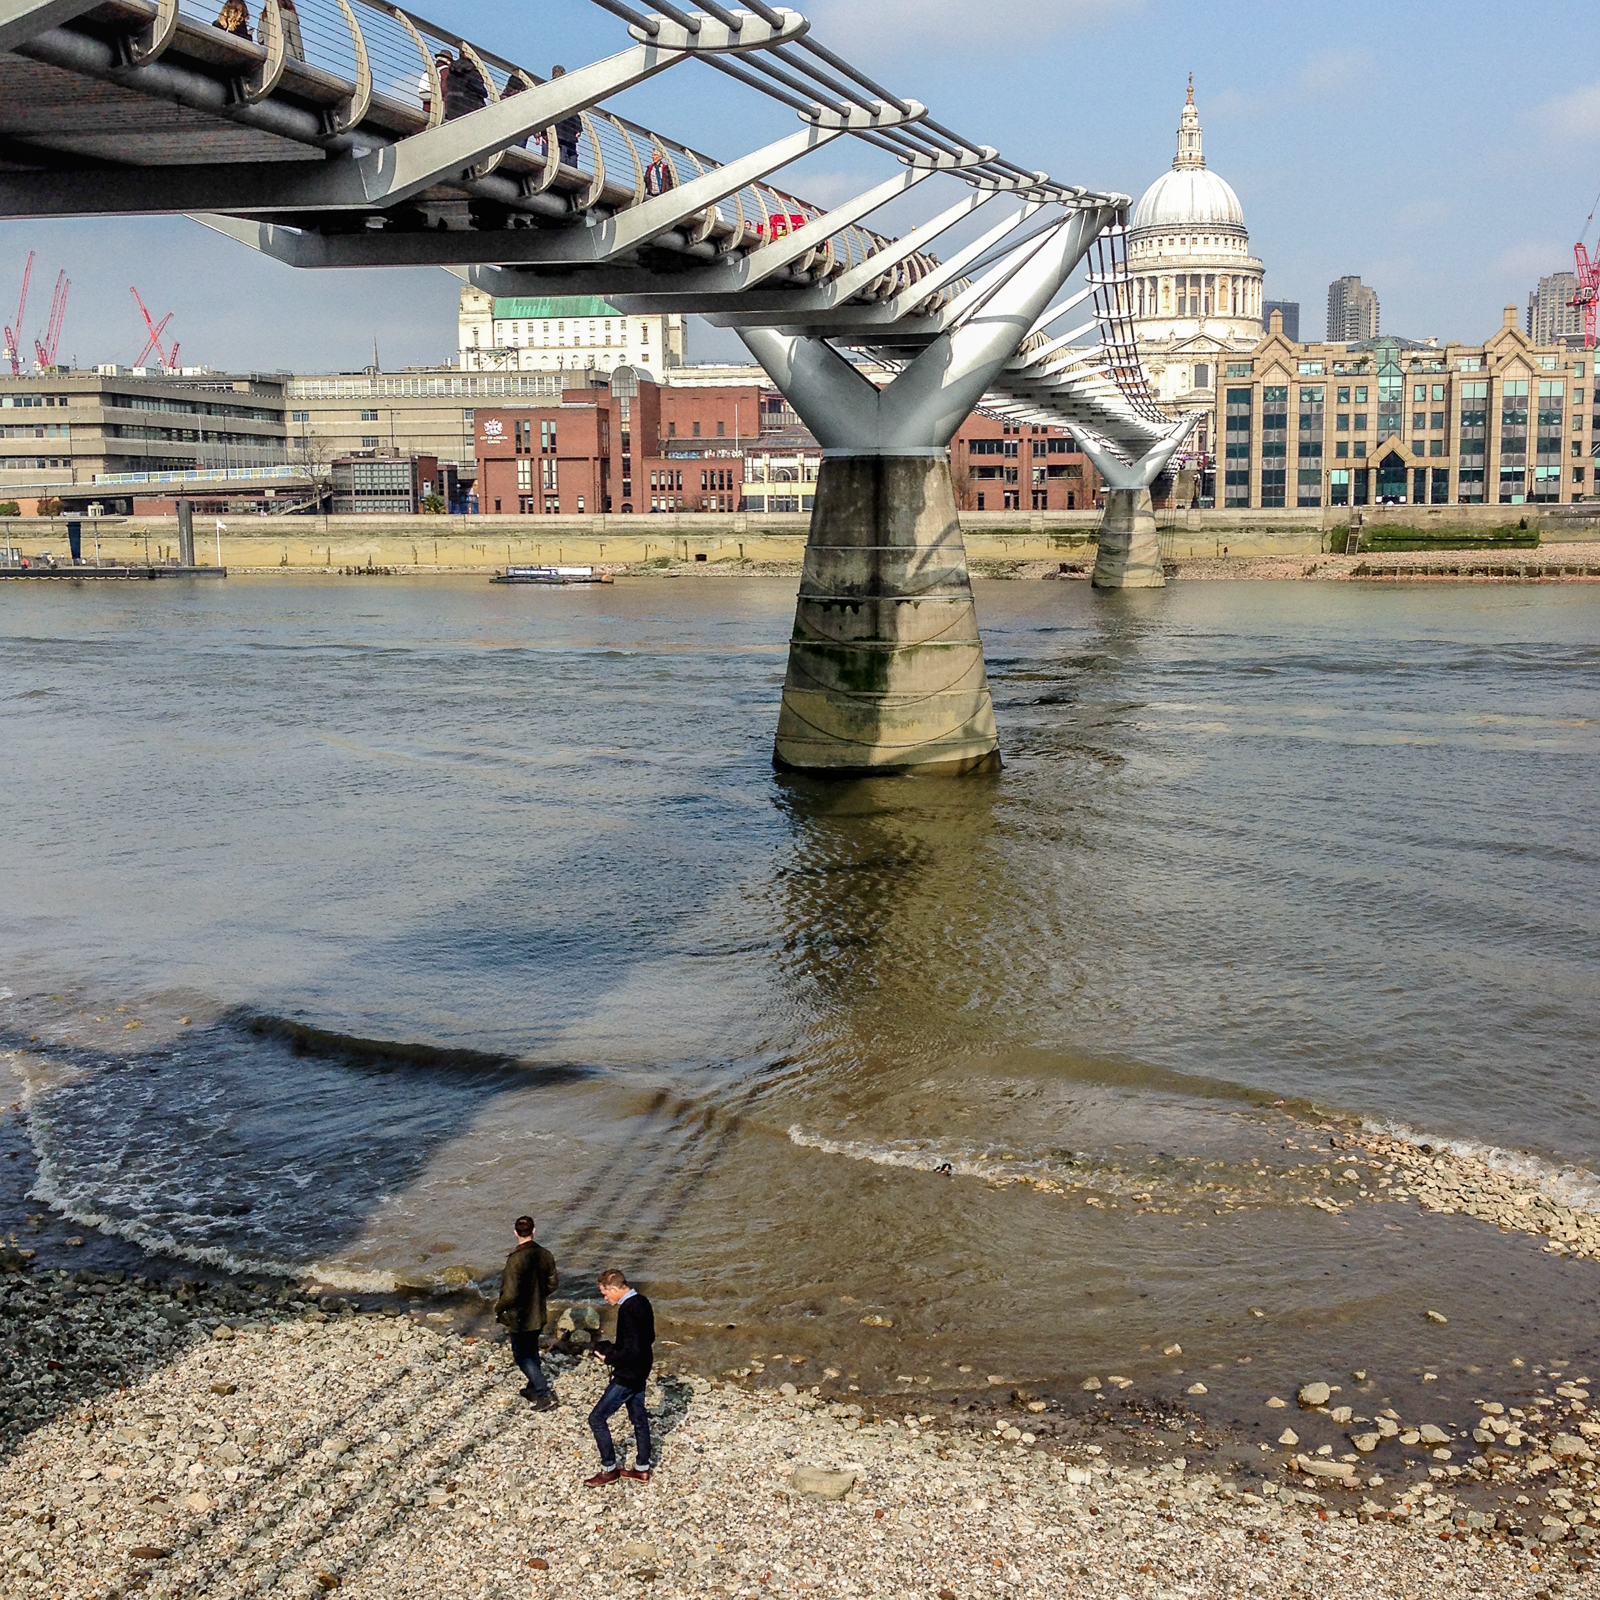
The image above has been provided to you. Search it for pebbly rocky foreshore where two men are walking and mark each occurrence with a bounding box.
[0,1262,1600,1600]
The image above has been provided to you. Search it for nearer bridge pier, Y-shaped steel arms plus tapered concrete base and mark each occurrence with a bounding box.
[739,210,1110,774]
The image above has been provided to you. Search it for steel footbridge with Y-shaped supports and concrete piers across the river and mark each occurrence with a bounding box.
[0,0,1195,773]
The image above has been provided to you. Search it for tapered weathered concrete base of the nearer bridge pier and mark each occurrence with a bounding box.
[773,456,1000,776]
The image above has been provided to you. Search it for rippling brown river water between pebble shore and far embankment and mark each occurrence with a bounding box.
[0,578,1600,1440]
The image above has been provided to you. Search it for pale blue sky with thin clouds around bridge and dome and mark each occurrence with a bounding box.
[0,0,1600,371]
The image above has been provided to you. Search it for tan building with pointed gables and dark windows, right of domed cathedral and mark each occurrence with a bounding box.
[1218,306,1600,509]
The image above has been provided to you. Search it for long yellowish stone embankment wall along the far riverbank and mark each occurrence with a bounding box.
[0,502,1600,573]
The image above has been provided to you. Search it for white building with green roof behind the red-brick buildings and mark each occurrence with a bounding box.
[458,288,685,379]
